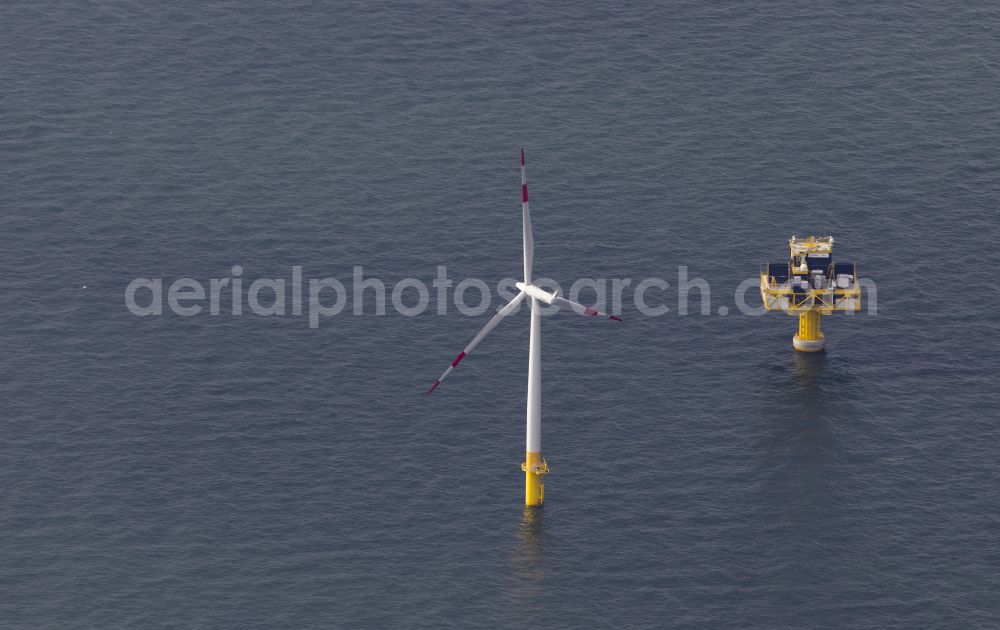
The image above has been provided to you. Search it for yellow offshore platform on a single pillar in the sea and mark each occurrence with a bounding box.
[760,236,861,352]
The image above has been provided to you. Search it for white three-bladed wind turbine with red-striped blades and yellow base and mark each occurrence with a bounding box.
[427,149,621,506]
